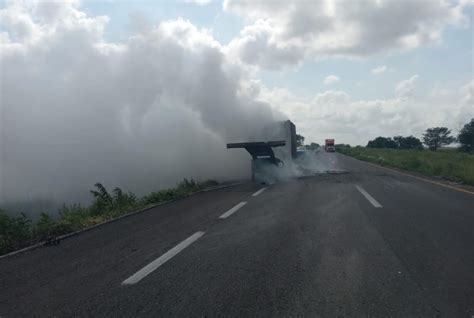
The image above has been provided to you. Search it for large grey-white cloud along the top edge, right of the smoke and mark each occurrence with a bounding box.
[224,0,468,69]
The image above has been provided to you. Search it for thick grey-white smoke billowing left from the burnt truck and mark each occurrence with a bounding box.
[0,2,281,211]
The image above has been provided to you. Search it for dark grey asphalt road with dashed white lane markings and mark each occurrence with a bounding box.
[0,153,474,318]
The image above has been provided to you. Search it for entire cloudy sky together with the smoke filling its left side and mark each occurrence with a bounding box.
[0,0,474,206]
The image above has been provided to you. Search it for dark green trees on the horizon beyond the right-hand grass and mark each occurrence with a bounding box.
[367,118,474,153]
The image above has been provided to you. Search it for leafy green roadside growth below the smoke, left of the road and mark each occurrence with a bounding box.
[0,179,217,255]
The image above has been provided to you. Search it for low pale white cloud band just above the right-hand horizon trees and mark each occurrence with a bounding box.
[254,77,474,145]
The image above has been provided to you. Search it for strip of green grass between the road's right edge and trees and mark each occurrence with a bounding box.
[337,147,474,185]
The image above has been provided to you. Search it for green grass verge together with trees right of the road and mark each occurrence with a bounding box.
[337,119,474,185]
